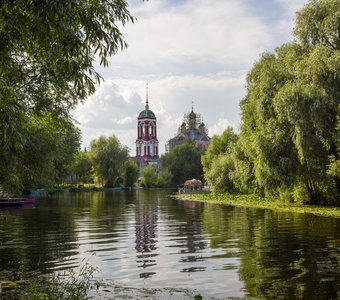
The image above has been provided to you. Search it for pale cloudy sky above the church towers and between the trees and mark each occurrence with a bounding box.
[74,0,307,156]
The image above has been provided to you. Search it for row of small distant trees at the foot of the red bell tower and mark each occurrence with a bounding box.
[74,135,203,188]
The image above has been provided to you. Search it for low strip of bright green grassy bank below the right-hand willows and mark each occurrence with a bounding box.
[178,194,340,218]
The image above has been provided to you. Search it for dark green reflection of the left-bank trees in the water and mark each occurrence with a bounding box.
[0,192,132,277]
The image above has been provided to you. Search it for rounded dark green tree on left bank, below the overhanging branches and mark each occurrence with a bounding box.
[0,114,80,193]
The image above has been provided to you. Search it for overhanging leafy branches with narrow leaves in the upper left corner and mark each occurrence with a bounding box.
[0,0,134,111]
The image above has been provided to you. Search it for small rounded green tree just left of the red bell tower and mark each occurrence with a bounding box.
[90,135,128,187]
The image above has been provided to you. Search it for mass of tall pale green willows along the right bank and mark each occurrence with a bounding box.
[202,0,340,205]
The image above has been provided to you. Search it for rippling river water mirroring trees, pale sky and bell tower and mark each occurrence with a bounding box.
[0,190,340,299]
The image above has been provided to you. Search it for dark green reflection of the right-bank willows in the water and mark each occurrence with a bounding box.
[204,205,340,299]
